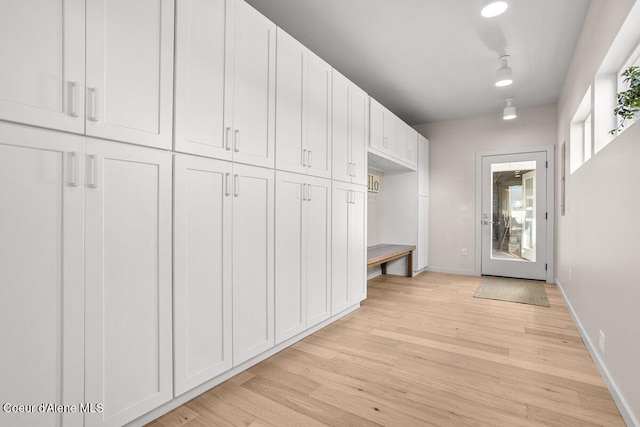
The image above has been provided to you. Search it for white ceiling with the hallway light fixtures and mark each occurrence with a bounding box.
[247,0,590,125]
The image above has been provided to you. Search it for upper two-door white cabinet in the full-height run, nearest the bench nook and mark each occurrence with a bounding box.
[332,70,369,185]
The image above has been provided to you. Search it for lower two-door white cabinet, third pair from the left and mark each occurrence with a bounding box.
[275,172,331,343]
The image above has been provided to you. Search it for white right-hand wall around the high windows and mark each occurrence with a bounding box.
[556,0,640,425]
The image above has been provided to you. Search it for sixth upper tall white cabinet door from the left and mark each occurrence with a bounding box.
[303,51,331,178]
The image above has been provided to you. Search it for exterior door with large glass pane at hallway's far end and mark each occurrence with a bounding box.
[480,151,548,280]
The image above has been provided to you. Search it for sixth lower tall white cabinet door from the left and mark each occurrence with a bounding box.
[304,178,331,328]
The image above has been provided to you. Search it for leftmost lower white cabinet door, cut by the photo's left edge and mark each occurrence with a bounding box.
[0,124,85,427]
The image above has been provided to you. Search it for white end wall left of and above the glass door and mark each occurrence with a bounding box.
[414,106,557,274]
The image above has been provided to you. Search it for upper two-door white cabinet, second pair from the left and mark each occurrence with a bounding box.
[175,0,276,167]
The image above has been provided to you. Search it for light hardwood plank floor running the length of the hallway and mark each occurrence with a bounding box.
[150,273,624,427]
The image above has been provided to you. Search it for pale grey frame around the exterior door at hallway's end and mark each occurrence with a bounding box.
[474,145,556,283]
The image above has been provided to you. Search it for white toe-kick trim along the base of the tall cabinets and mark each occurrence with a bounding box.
[126,303,360,427]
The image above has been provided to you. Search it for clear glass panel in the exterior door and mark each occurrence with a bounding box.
[486,161,536,262]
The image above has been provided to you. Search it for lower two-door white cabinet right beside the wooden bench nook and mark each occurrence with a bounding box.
[331,181,367,315]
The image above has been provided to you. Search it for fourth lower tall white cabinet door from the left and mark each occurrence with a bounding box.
[232,165,274,366]
